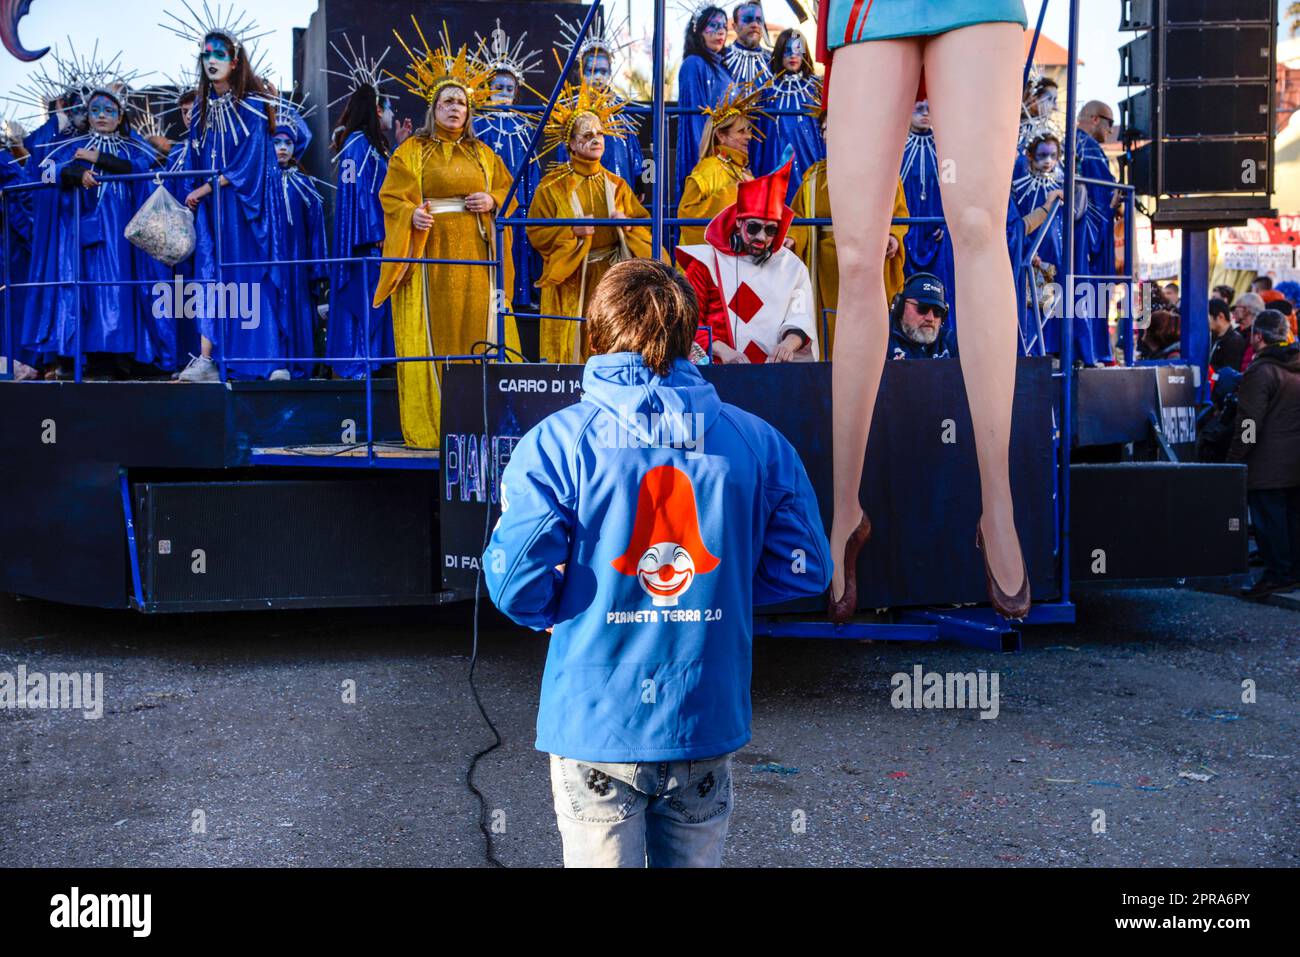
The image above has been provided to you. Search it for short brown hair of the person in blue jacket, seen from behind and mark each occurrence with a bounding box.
[586,259,699,376]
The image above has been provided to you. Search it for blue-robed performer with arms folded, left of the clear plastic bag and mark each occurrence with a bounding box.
[26,85,159,373]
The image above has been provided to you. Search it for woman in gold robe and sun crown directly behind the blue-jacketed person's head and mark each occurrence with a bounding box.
[528,82,653,364]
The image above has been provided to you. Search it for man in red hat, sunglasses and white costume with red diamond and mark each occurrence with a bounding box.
[677,150,820,364]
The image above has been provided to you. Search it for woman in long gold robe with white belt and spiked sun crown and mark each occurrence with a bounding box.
[374,17,519,449]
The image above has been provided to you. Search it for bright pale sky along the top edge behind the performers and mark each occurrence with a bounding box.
[0,0,1282,121]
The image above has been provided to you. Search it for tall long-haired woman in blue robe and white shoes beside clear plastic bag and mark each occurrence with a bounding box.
[181,23,290,382]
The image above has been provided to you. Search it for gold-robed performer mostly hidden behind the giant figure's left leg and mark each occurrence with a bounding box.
[790,160,907,359]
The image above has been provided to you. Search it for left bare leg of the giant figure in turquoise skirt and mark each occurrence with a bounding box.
[827,39,925,598]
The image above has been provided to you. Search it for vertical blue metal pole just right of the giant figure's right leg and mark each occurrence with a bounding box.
[1060,0,1079,603]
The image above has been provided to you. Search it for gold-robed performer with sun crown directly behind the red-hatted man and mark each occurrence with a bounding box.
[677,83,767,246]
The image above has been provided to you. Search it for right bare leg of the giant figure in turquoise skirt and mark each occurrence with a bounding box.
[930,23,1024,594]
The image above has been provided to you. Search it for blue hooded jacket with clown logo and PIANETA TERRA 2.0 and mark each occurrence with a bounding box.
[484,352,831,762]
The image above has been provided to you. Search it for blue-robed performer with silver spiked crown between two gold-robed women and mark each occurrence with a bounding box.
[473,27,541,306]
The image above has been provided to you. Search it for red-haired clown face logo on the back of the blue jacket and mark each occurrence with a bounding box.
[614,465,719,609]
